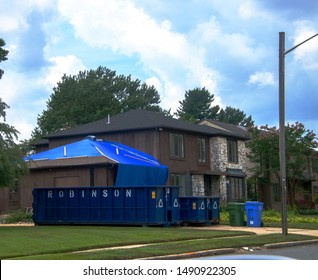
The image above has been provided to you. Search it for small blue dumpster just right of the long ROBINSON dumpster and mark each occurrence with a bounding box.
[180,196,211,224]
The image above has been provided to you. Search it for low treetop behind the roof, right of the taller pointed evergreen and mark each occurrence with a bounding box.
[217,106,254,127]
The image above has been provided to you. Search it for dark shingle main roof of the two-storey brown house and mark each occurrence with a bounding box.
[46,109,245,139]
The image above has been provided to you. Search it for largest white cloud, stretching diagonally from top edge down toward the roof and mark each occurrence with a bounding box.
[58,0,221,110]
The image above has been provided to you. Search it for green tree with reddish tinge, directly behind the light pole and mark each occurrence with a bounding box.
[247,122,318,207]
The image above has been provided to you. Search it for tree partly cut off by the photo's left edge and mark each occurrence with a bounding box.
[0,38,27,187]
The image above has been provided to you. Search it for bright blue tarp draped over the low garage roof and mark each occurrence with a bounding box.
[24,137,168,186]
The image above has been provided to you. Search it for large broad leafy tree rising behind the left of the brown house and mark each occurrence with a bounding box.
[32,66,161,138]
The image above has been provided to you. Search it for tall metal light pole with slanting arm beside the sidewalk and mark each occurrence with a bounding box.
[279,32,318,235]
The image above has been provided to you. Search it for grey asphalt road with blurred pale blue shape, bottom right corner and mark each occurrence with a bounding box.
[195,244,318,260]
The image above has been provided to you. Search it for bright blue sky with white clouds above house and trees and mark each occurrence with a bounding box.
[0,0,318,139]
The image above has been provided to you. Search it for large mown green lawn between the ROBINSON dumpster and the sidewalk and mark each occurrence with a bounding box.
[0,226,248,259]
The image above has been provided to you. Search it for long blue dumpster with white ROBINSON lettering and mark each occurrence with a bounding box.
[33,186,180,226]
